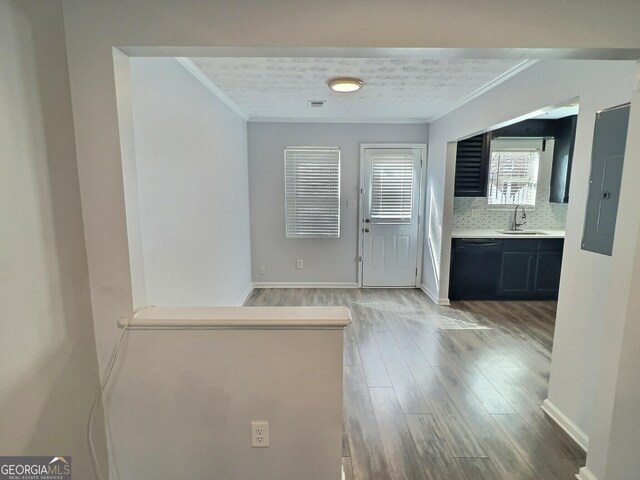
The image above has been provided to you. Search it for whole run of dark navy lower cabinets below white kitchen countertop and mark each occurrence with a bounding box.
[449,239,564,300]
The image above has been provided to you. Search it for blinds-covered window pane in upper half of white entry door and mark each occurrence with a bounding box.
[371,155,414,223]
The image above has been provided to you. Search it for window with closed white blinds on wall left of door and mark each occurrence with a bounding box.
[284,147,340,238]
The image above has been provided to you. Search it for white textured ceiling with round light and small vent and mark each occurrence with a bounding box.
[191,57,522,120]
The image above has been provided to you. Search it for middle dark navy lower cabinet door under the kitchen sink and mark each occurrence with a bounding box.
[498,251,536,298]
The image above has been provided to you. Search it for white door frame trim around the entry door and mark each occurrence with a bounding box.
[356,143,427,288]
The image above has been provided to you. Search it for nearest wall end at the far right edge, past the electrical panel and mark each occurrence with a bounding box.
[585,71,640,480]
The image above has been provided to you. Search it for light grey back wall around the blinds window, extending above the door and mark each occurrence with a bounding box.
[249,123,427,284]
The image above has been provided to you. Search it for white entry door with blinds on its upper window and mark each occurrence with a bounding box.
[361,148,422,287]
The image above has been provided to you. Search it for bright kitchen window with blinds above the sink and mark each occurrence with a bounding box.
[487,138,542,207]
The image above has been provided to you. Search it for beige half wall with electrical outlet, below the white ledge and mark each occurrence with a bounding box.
[105,329,343,480]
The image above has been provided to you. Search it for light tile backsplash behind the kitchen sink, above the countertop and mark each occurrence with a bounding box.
[453,186,568,230]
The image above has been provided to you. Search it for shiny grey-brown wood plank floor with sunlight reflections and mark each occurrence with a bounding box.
[247,289,585,480]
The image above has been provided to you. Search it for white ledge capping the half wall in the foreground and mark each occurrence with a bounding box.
[118,307,351,330]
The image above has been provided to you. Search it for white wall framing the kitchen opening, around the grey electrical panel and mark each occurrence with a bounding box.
[423,61,634,446]
